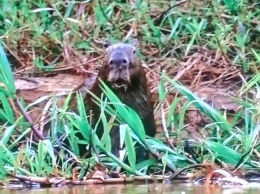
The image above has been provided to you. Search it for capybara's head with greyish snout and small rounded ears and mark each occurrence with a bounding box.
[105,40,141,89]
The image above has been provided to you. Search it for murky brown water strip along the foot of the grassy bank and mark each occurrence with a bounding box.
[0,183,260,194]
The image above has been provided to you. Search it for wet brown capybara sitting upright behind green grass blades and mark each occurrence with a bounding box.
[86,40,156,160]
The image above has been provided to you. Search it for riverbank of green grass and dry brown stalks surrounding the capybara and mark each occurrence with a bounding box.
[0,0,260,188]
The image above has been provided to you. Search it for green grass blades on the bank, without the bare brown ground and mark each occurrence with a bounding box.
[0,0,260,182]
